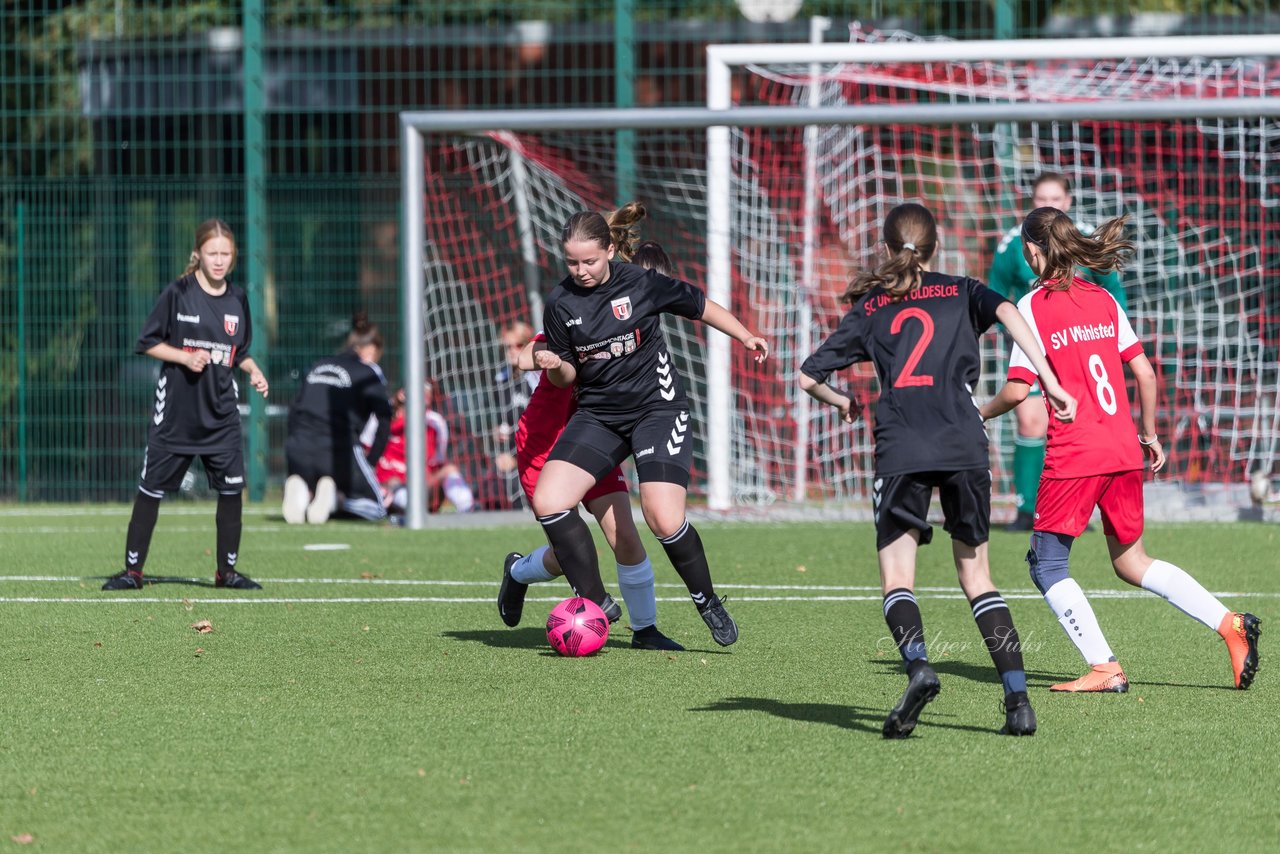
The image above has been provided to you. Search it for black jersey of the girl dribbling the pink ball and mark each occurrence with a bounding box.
[543,261,707,416]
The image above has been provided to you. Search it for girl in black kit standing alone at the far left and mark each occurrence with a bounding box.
[102,219,268,590]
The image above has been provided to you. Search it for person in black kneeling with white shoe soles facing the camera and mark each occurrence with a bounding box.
[283,312,392,525]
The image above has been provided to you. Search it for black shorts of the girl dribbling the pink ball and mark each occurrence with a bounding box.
[548,408,694,489]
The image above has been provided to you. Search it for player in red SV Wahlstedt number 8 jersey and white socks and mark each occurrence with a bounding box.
[982,207,1261,693]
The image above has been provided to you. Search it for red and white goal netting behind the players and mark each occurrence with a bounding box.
[414,35,1280,516]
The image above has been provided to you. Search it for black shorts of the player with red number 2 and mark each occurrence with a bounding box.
[872,469,991,551]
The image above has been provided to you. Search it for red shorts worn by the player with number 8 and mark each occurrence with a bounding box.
[1036,470,1143,544]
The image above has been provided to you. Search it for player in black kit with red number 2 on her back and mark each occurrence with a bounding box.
[800,204,1075,739]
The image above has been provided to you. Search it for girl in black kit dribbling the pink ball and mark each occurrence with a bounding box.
[534,202,769,647]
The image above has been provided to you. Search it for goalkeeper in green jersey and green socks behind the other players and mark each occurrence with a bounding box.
[987,172,1128,531]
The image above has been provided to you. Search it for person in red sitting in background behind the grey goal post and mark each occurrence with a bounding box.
[375,380,476,513]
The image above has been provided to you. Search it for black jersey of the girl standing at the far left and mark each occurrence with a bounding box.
[134,275,253,453]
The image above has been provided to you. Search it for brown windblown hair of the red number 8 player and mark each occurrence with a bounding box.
[1021,207,1133,291]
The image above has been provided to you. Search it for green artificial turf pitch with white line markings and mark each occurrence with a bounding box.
[0,504,1280,851]
